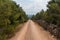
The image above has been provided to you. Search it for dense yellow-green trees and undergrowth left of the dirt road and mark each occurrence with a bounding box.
[0,0,28,40]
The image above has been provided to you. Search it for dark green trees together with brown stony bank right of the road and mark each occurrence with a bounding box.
[31,0,60,40]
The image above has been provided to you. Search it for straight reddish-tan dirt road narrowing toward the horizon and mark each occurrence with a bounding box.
[10,20,55,40]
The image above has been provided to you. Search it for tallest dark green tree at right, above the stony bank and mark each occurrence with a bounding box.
[47,0,60,25]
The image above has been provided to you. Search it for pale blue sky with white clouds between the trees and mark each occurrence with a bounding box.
[13,0,49,15]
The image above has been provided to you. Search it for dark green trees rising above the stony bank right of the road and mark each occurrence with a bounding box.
[32,0,60,40]
